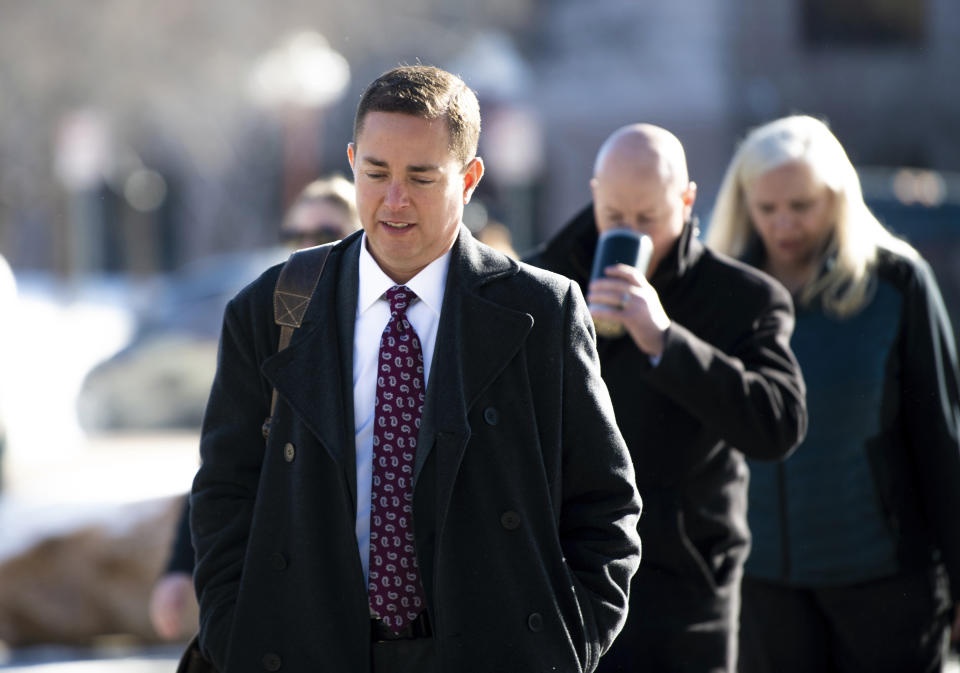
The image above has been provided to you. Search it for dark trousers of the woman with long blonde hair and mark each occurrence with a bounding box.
[740,570,949,673]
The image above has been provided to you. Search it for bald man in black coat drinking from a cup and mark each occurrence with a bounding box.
[526,124,806,673]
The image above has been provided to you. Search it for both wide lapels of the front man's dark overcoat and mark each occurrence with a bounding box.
[263,226,533,523]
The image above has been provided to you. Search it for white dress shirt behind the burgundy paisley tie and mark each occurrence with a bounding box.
[353,234,450,584]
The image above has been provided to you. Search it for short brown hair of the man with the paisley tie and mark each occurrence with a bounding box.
[353,65,480,166]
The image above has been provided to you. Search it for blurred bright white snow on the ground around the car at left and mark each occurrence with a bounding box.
[0,277,199,558]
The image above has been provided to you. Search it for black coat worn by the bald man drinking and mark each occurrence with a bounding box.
[528,206,807,591]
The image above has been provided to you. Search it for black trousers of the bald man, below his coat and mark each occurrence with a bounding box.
[597,565,740,673]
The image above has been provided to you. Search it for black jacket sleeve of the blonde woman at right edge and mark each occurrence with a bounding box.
[871,248,960,604]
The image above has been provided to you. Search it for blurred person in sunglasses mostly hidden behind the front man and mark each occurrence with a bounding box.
[150,173,360,640]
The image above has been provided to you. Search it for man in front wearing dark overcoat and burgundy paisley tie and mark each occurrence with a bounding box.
[185,65,640,673]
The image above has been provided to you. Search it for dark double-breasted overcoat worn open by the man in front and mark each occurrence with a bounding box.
[191,227,640,673]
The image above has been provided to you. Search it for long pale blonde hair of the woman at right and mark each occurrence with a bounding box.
[706,115,917,317]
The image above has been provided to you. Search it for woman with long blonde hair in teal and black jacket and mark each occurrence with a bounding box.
[707,116,960,673]
